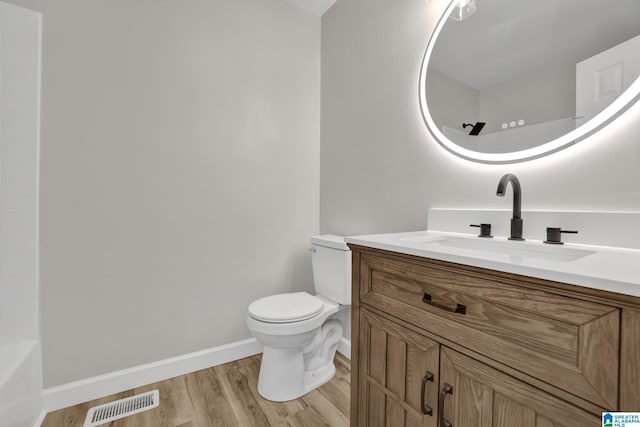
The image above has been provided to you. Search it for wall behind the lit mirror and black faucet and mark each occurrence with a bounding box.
[320,0,640,239]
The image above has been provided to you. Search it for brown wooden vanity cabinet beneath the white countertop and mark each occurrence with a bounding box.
[350,245,640,427]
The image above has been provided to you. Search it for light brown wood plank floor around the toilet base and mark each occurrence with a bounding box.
[42,354,351,427]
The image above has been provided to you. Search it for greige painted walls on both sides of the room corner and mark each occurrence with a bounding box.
[6,0,640,387]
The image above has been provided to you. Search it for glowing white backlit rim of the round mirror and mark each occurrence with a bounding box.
[418,0,640,164]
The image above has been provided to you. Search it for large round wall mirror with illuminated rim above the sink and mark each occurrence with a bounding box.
[419,0,640,163]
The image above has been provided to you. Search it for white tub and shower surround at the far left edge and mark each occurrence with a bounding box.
[0,2,42,427]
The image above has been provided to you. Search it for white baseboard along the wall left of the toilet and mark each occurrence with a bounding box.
[44,338,262,412]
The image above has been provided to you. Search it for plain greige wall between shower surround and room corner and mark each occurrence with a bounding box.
[6,0,320,387]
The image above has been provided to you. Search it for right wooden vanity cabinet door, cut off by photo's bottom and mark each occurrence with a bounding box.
[440,347,601,427]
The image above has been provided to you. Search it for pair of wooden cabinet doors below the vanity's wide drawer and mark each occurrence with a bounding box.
[360,309,600,427]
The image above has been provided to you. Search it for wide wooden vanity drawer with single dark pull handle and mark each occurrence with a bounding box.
[359,253,620,410]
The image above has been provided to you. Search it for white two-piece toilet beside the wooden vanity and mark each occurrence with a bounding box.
[247,235,351,402]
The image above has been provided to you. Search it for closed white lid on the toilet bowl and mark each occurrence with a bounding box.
[249,292,324,323]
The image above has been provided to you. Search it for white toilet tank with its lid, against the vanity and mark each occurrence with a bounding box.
[311,234,351,305]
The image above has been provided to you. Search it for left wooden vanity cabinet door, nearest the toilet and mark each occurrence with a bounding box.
[358,309,440,427]
